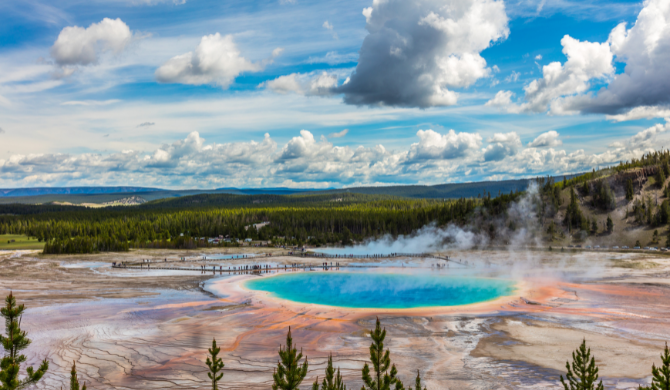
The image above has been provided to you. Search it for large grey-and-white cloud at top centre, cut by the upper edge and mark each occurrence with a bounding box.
[337,0,509,108]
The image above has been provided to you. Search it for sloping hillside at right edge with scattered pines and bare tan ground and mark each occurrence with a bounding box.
[542,150,670,248]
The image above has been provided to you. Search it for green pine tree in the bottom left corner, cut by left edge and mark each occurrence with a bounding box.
[0,292,49,390]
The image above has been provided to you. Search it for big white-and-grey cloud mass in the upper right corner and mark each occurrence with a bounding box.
[490,0,670,121]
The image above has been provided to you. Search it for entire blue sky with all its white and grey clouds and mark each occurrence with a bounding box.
[0,0,670,188]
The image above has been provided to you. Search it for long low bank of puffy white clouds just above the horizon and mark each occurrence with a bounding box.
[0,122,670,188]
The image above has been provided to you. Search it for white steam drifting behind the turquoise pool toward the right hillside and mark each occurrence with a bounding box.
[324,183,626,280]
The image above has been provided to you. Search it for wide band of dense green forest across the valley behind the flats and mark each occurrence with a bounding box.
[0,192,521,253]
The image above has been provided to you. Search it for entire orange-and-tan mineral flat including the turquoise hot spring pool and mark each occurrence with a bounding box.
[0,250,670,390]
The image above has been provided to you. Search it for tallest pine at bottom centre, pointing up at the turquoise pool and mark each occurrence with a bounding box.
[361,318,404,390]
